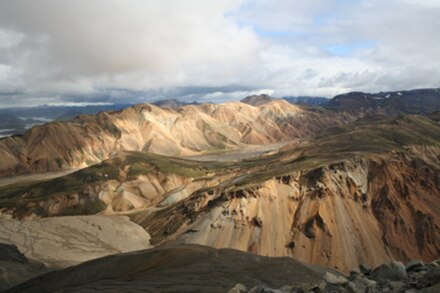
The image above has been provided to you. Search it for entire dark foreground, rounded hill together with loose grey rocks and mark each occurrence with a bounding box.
[0,245,440,293]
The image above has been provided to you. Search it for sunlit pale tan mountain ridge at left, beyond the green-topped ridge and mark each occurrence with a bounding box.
[0,100,356,177]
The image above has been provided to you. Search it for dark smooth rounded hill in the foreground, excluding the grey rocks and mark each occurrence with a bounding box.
[6,245,325,293]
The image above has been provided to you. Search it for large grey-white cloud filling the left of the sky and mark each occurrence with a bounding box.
[0,0,259,105]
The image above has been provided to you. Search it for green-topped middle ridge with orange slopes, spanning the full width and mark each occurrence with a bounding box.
[0,113,440,272]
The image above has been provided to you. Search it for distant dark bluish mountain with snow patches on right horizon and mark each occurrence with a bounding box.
[327,89,440,115]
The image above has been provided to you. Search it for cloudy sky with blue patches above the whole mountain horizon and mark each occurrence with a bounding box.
[0,0,440,107]
